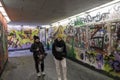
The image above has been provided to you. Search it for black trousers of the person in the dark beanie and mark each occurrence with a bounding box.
[33,55,44,73]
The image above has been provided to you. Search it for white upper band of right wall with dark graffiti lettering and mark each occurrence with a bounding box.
[74,2,120,26]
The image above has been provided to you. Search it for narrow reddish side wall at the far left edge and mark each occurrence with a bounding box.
[0,13,8,73]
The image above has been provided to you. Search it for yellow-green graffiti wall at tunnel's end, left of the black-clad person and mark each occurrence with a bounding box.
[8,25,39,50]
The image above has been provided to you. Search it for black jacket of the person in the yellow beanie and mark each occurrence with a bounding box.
[52,39,67,60]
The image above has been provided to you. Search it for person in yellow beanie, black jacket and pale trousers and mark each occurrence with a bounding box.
[52,34,67,80]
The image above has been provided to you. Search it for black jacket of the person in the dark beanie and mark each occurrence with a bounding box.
[30,42,45,56]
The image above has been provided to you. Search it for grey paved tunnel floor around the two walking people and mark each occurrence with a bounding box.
[1,51,113,80]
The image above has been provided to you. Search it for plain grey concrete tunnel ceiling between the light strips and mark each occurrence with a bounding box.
[2,0,112,25]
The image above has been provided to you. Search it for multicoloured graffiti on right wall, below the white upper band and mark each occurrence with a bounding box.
[65,22,120,76]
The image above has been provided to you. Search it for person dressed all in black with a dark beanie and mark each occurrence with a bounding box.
[30,36,45,76]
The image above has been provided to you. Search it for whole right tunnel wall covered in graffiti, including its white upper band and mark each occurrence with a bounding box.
[52,2,120,77]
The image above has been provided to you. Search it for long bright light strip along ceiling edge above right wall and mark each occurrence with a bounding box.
[52,0,120,26]
